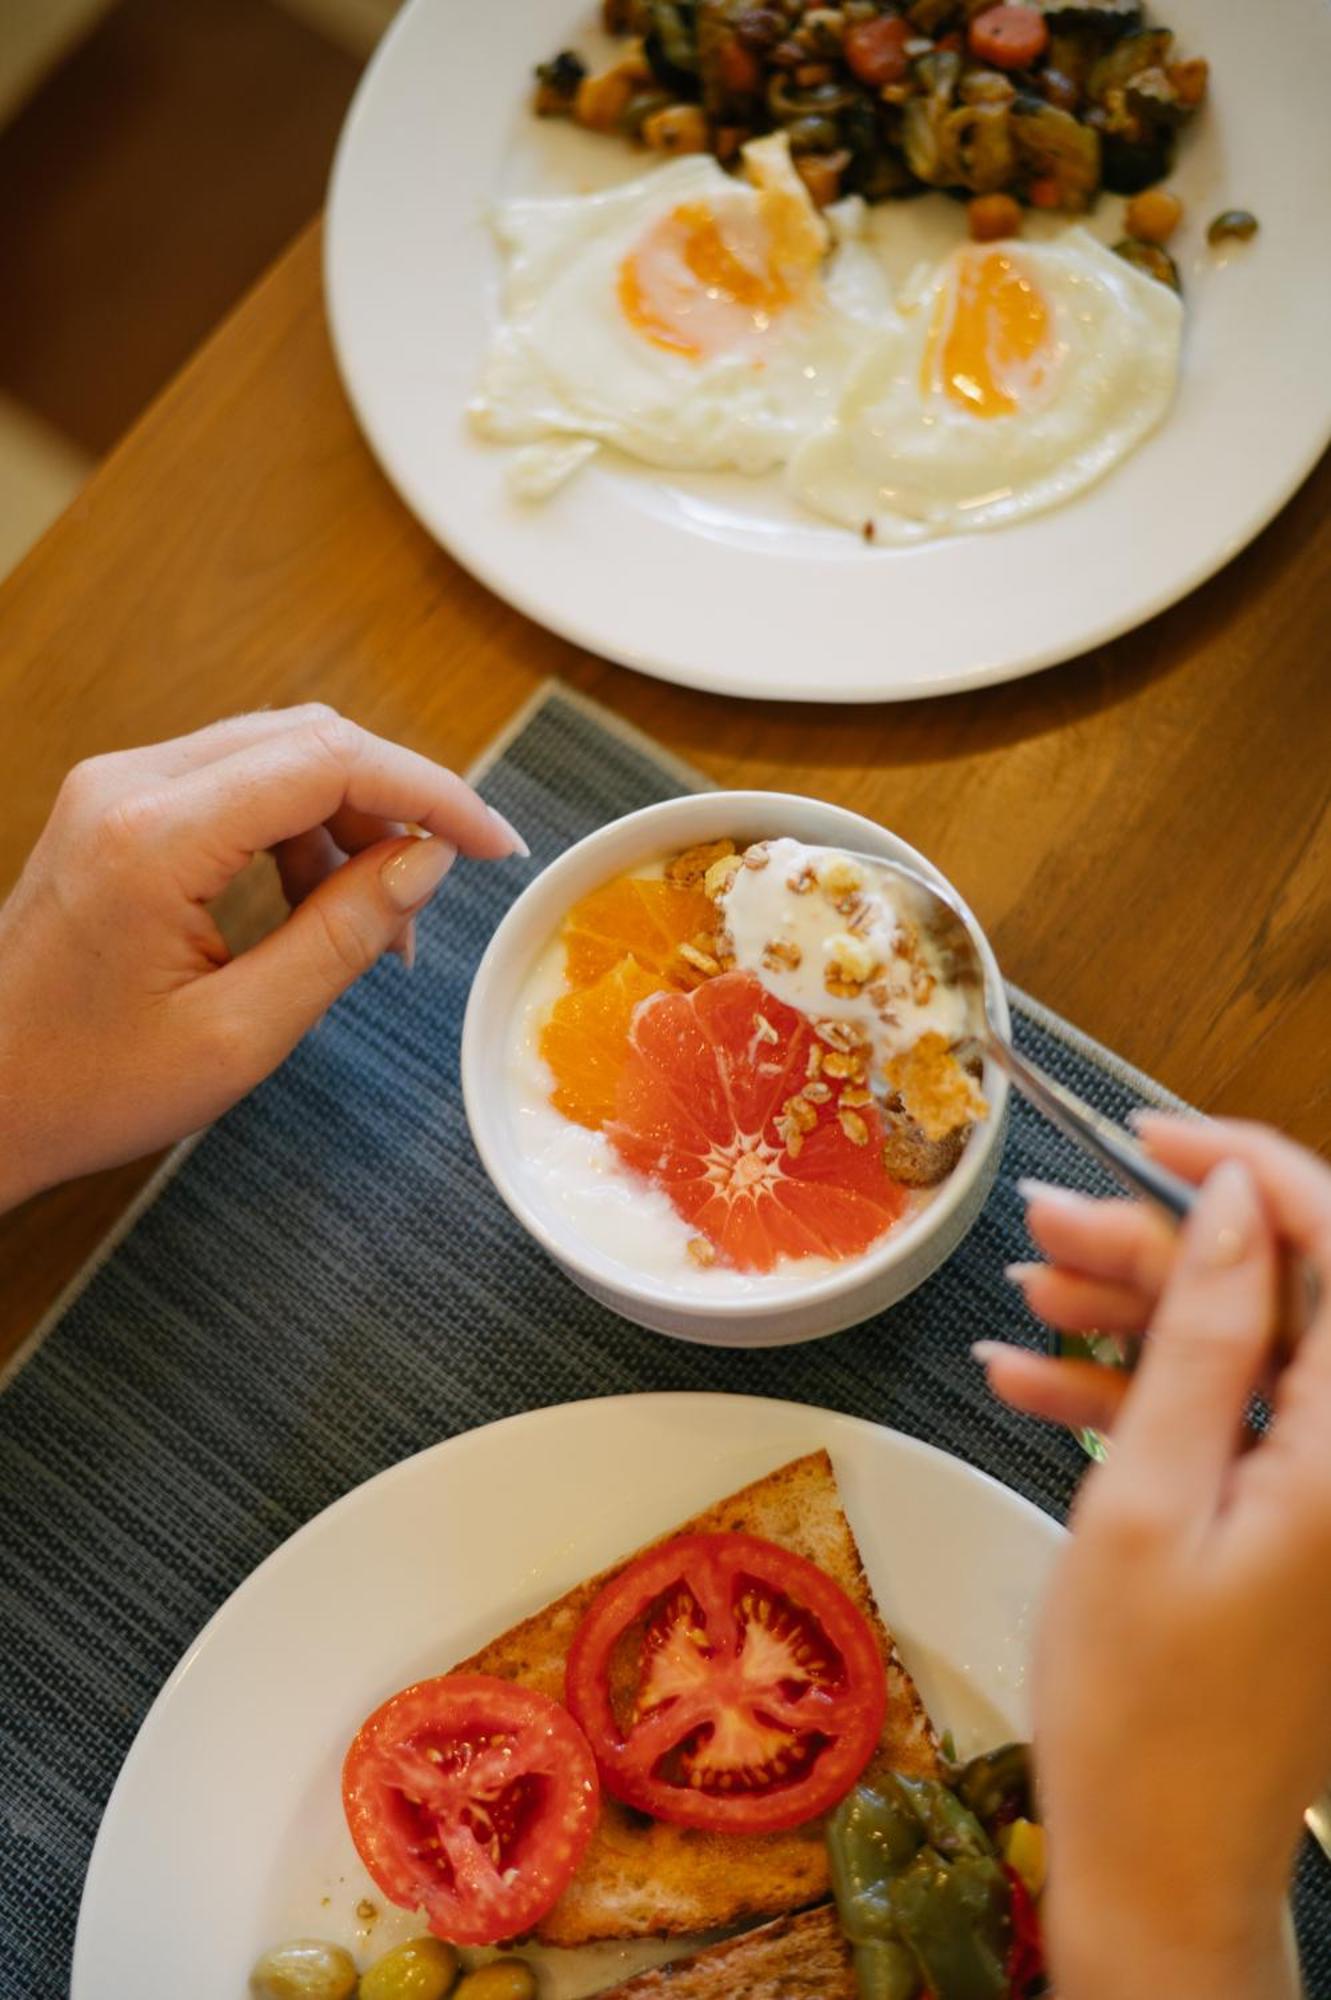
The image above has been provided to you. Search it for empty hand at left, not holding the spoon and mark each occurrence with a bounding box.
[0,704,526,1210]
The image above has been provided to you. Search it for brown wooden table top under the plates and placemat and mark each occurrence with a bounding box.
[0,228,1331,1356]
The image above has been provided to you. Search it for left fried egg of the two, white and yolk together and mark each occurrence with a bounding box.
[470,136,891,496]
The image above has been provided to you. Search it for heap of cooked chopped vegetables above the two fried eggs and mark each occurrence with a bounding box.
[536,0,1207,212]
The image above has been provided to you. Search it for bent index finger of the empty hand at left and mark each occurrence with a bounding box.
[140,716,526,898]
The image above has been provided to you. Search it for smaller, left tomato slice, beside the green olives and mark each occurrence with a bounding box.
[342,1674,600,1944]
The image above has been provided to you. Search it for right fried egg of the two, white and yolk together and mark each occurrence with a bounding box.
[787,228,1183,542]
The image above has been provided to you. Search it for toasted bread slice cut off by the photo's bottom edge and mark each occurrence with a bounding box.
[596,1902,859,2000]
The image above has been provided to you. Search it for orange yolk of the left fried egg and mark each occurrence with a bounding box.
[618,200,807,360]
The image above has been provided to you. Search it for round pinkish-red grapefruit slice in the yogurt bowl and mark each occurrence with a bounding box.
[606,972,905,1272]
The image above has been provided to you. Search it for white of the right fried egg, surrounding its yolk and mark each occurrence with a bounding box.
[787,228,1183,542]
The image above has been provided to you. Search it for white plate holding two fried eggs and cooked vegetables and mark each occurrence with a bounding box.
[326,0,1331,702]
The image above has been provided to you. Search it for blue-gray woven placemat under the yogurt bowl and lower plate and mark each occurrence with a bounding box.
[0,694,1331,2000]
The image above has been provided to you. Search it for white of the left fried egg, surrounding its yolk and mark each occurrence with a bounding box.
[470,140,893,498]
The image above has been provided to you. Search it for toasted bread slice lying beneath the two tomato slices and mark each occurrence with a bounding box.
[456,1452,937,1944]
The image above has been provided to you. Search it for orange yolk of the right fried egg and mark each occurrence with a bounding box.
[921,250,1055,418]
